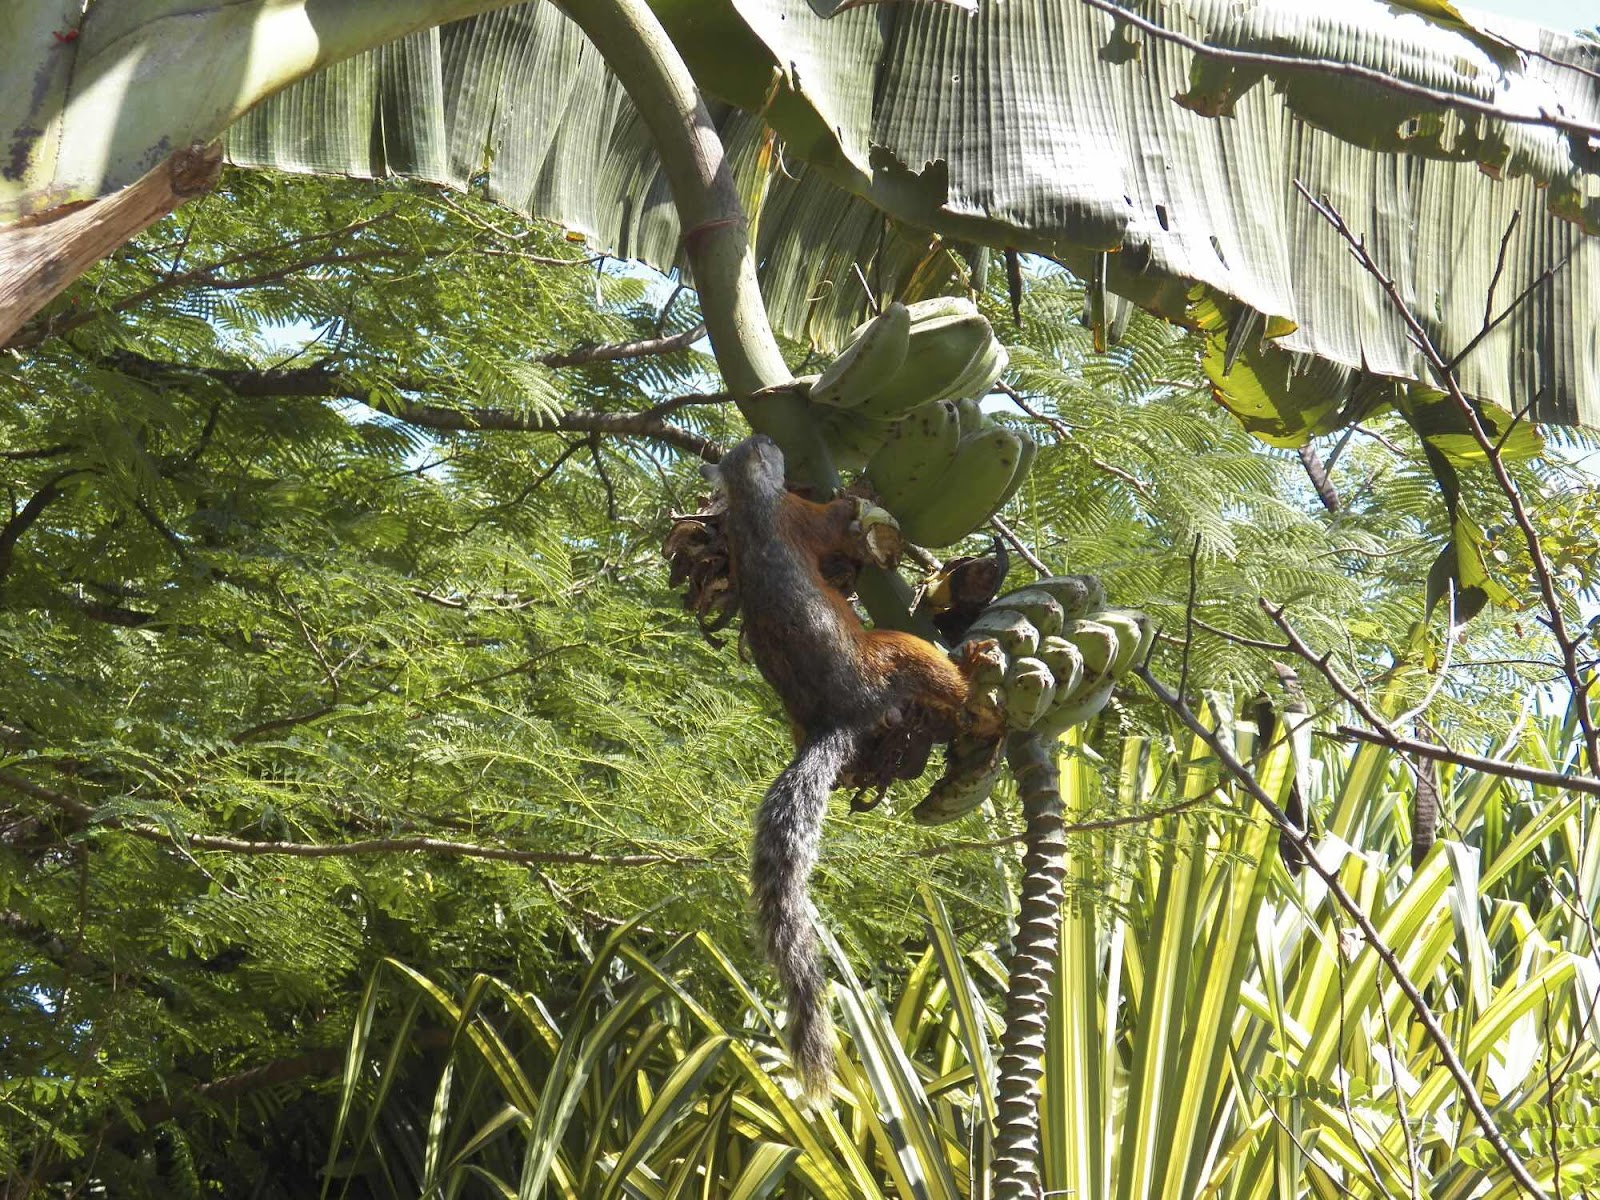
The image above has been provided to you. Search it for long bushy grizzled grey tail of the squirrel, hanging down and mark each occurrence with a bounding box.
[750,730,856,1098]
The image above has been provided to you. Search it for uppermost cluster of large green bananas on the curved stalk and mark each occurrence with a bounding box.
[810,296,1006,470]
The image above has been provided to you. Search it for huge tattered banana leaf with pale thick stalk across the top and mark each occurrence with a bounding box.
[0,0,1600,435]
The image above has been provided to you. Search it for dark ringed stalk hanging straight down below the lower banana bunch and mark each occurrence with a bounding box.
[992,731,1067,1200]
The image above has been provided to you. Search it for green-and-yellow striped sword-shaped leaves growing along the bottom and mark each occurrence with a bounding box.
[333,714,1600,1200]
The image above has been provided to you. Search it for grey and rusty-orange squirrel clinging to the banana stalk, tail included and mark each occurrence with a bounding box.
[709,434,973,1099]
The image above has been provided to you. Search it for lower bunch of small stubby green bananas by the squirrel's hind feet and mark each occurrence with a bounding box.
[912,574,1155,824]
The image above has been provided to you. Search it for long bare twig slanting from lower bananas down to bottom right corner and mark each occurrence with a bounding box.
[1134,666,1542,1197]
